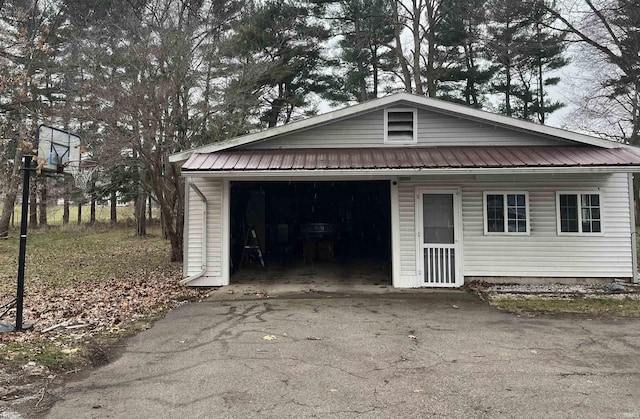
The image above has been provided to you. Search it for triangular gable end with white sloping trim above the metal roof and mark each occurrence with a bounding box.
[170,93,624,162]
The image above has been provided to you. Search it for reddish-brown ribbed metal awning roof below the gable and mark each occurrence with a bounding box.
[182,146,640,172]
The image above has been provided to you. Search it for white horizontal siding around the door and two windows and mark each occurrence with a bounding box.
[398,174,633,286]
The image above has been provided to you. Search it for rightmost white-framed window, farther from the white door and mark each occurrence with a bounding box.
[556,192,602,233]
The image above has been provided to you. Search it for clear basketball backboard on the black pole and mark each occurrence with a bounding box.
[37,125,81,173]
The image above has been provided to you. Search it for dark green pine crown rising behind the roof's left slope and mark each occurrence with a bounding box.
[221,0,329,127]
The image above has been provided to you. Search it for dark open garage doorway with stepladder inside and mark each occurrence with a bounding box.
[230,181,391,285]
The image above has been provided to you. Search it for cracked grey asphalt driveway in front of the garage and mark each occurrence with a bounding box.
[50,292,640,418]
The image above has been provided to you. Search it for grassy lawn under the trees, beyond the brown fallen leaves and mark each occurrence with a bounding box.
[0,226,171,294]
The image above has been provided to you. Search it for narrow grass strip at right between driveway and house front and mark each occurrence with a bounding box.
[490,297,640,318]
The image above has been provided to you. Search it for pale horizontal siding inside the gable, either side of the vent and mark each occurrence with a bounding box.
[243,108,570,149]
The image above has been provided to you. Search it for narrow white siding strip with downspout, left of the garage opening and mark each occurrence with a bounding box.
[184,178,223,286]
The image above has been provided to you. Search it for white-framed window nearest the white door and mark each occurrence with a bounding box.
[483,192,529,234]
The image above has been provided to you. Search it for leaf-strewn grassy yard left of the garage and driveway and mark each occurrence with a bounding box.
[0,228,209,359]
